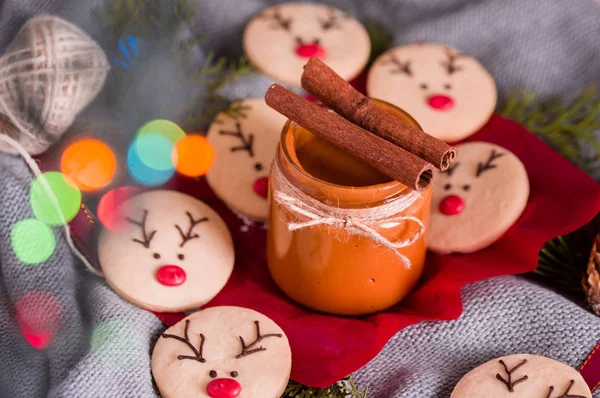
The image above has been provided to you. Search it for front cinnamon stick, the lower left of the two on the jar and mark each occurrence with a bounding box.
[265,84,433,191]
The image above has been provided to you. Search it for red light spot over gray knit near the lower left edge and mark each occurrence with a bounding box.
[15,292,63,350]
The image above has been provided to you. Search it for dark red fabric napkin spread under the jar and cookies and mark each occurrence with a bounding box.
[59,116,600,387]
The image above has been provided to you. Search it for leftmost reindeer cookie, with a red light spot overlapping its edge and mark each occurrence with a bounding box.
[98,190,234,312]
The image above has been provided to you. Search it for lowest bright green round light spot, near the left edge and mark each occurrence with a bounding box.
[10,218,56,264]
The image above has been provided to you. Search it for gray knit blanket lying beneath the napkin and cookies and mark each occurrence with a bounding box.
[0,0,600,398]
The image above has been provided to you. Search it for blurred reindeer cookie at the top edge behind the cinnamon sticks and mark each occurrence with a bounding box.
[244,3,371,86]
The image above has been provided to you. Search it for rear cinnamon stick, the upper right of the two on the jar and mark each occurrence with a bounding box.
[301,57,456,171]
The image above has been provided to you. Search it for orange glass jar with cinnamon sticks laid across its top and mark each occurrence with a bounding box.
[267,100,432,315]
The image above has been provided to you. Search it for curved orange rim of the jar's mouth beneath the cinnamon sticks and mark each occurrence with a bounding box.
[276,98,422,199]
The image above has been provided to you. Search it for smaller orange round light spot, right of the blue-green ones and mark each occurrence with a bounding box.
[173,135,215,177]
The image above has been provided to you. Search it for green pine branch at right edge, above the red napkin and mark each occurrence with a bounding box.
[500,85,600,177]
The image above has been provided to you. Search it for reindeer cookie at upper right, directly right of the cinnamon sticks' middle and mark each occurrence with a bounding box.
[367,43,497,142]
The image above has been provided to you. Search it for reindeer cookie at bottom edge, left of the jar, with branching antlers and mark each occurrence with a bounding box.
[152,307,292,398]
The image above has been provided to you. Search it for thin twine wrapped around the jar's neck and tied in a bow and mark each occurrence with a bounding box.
[273,162,425,269]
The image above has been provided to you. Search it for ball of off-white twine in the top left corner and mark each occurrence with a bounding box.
[0,16,109,155]
